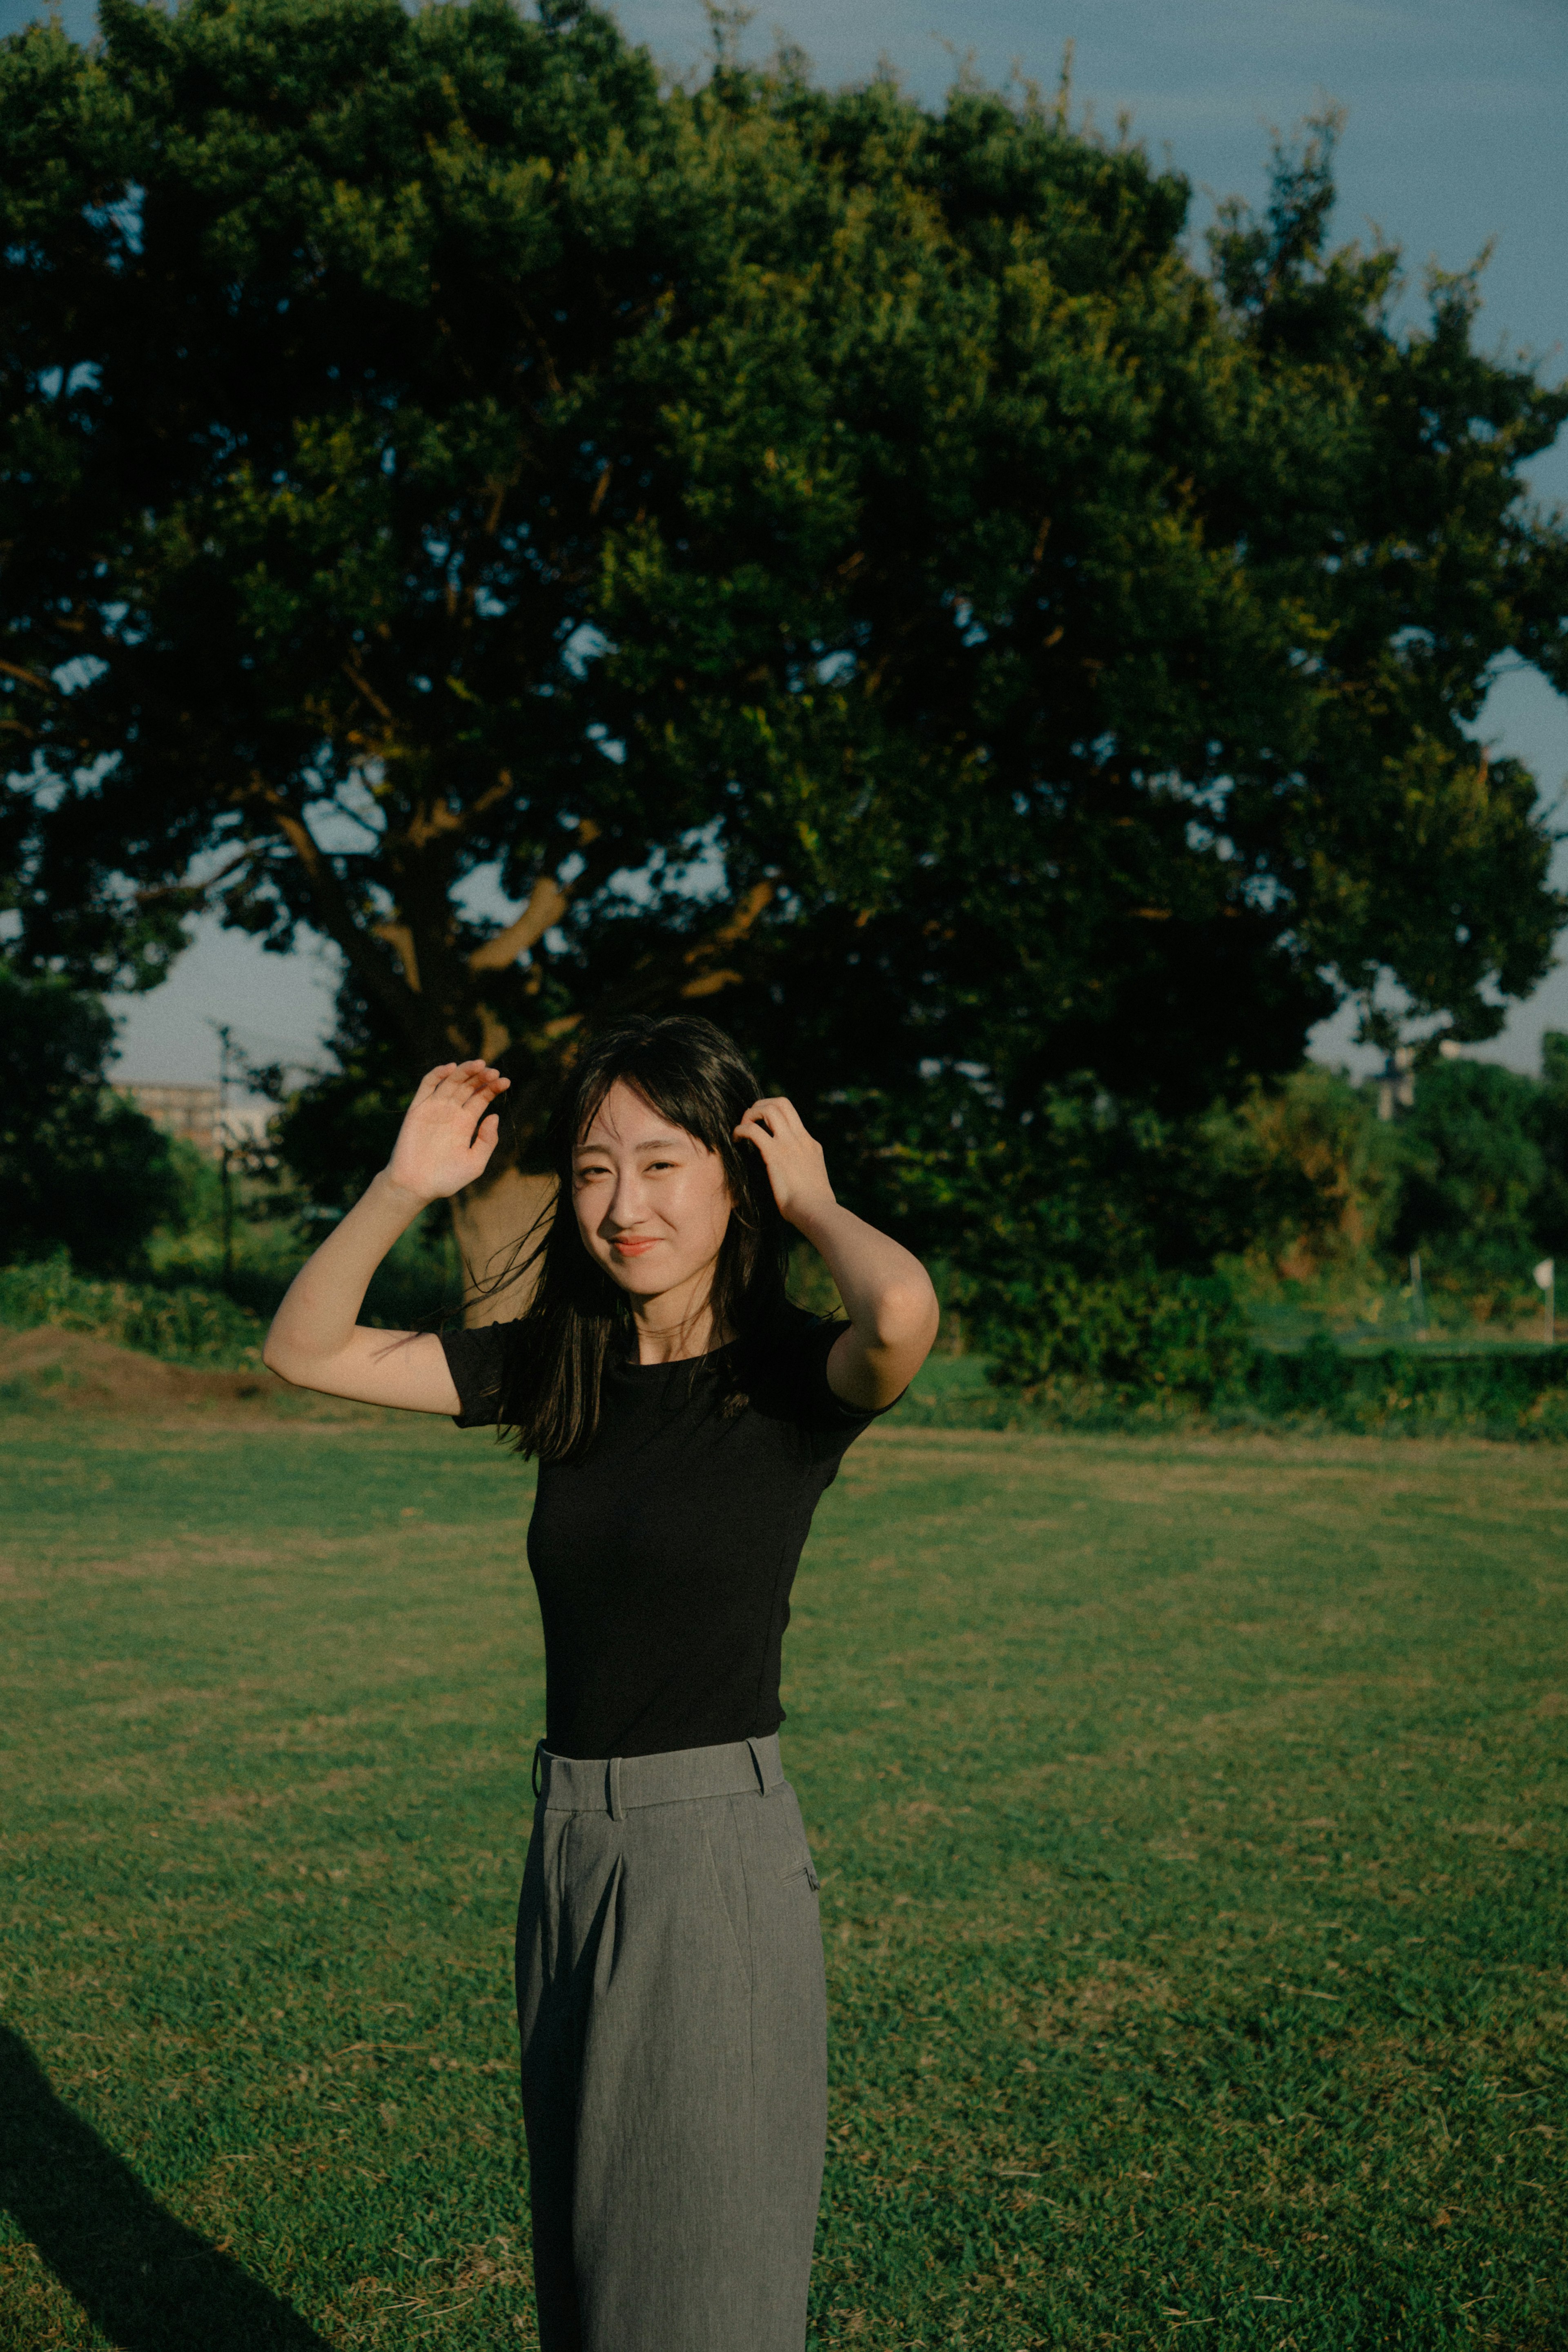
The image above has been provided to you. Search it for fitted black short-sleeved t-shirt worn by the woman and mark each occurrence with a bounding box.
[442,1308,875,1757]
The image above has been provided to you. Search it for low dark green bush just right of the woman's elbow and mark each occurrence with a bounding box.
[971,1275,1251,1404]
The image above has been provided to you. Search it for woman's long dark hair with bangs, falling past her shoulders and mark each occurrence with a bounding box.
[487,1014,790,1460]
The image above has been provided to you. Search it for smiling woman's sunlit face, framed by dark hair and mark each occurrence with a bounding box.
[571,1082,729,1298]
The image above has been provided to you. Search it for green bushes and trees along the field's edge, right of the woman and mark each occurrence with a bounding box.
[940,1035,1568,1402]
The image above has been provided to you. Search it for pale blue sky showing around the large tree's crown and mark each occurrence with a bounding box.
[0,0,1568,1077]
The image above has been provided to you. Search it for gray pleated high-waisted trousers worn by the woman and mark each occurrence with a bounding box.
[517,1738,828,2352]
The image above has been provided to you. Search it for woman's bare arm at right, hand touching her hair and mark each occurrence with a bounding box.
[736,1094,943,1411]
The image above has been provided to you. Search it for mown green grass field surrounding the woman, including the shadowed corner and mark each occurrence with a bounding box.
[0,1407,1568,2352]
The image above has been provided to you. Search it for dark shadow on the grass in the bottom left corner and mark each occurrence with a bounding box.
[0,2025,327,2352]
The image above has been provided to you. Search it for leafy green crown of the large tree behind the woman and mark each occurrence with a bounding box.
[0,0,1568,1260]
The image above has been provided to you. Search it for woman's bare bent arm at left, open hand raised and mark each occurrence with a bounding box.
[261,1061,510,1413]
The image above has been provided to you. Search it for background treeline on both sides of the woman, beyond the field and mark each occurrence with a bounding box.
[0,967,1568,1320]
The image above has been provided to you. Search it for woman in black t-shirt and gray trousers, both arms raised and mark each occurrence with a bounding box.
[266,1019,938,2352]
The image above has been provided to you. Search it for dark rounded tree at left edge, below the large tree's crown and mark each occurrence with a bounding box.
[0,960,181,1273]
